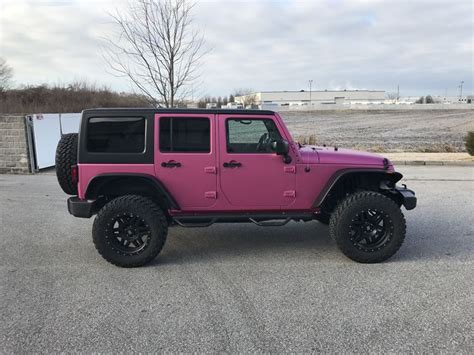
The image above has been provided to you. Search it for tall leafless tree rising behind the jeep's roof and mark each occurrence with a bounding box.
[104,0,207,107]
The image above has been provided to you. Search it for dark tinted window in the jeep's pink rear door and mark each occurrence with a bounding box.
[160,117,211,153]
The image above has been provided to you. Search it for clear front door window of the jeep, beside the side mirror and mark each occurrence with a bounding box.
[226,119,281,153]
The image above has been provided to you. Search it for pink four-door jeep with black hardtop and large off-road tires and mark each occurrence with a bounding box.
[56,109,416,267]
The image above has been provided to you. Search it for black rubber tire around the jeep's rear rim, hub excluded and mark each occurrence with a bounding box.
[92,195,168,267]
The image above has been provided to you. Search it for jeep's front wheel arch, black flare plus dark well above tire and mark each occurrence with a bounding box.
[312,169,403,208]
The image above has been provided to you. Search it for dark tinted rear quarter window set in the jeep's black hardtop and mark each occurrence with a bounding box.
[87,117,145,153]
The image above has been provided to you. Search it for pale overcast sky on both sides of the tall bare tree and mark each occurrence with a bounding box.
[0,0,474,96]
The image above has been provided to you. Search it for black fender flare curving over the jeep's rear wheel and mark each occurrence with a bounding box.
[84,173,180,210]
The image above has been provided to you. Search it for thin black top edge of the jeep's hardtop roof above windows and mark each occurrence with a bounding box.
[82,107,275,115]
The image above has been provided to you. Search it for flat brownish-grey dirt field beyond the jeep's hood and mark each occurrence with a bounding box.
[280,110,474,152]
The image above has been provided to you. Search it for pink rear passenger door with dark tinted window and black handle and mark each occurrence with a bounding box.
[155,113,217,209]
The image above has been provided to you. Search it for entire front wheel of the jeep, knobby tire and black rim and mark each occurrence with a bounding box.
[329,191,406,263]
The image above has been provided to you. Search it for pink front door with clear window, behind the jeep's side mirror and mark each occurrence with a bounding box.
[218,114,296,210]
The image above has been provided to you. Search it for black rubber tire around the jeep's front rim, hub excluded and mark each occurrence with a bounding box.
[329,191,406,263]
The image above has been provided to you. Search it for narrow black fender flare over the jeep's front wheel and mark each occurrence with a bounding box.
[311,168,403,209]
